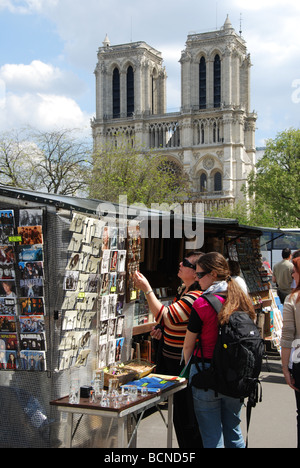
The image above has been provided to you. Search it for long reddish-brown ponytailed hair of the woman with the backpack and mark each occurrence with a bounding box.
[197,252,256,325]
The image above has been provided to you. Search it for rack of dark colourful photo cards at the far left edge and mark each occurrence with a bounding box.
[0,209,47,372]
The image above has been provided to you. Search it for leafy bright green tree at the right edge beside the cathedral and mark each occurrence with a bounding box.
[247,128,300,227]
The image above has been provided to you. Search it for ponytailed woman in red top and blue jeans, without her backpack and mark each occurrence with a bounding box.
[183,252,255,448]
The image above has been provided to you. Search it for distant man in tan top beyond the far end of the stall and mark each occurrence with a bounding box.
[272,247,293,304]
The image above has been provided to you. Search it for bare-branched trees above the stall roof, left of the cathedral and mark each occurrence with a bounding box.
[0,128,91,195]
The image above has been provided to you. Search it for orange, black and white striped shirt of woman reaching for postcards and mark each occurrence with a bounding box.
[156,291,202,360]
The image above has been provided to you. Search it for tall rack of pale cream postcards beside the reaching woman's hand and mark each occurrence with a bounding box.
[58,214,141,371]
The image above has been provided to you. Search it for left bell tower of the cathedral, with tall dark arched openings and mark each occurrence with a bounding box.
[95,36,166,146]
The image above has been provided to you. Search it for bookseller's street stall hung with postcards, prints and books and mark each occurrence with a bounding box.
[0,186,276,448]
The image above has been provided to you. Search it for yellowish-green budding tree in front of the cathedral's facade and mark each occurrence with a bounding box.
[89,137,189,206]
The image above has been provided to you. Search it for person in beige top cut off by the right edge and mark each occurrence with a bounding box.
[281,257,300,448]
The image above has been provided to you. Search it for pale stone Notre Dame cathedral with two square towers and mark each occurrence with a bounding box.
[92,17,257,211]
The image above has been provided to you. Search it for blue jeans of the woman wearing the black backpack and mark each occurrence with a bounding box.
[190,364,245,448]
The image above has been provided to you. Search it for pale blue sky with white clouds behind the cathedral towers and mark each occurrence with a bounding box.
[0,0,300,146]
